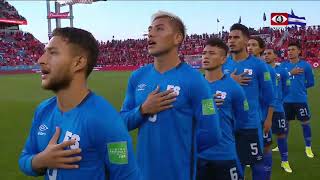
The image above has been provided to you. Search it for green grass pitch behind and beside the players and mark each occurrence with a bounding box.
[0,71,320,180]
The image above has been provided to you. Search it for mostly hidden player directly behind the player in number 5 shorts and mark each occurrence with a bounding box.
[247,36,276,179]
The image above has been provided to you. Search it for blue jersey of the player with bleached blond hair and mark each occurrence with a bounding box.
[121,63,221,180]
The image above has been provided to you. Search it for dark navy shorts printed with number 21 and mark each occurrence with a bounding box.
[283,103,311,121]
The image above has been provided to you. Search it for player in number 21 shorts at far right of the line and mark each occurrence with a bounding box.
[281,42,314,158]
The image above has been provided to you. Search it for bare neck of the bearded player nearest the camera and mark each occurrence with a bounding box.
[56,77,89,112]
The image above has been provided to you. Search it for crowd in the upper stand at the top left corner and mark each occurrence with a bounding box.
[0,0,26,20]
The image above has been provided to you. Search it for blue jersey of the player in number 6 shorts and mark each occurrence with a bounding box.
[199,75,249,160]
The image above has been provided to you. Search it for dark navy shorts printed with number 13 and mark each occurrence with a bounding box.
[272,112,288,134]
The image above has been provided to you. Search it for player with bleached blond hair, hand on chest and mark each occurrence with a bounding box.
[120,11,221,180]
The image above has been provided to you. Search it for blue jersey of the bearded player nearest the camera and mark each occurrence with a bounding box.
[19,92,141,180]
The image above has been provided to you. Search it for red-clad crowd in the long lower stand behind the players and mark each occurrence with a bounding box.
[0,25,320,66]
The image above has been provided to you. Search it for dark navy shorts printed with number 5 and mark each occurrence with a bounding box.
[235,128,263,165]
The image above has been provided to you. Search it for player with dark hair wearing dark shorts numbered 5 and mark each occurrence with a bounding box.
[223,24,273,180]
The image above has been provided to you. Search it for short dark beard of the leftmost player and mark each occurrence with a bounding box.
[42,71,72,93]
